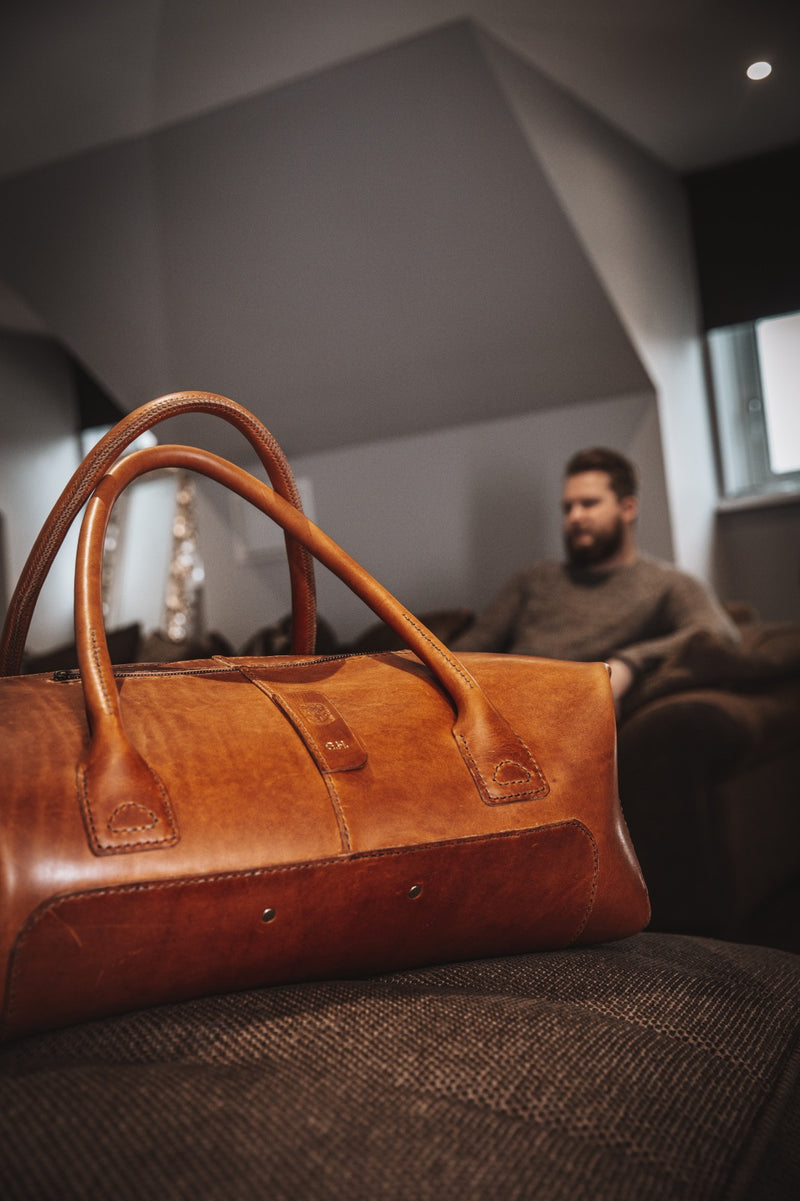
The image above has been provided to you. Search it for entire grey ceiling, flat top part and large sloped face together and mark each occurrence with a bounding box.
[0,0,800,453]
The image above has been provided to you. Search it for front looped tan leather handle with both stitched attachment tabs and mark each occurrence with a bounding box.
[76,446,548,854]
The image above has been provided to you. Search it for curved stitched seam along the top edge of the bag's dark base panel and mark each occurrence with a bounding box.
[0,818,599,1023]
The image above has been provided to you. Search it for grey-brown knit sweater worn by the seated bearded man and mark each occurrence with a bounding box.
[453,557,738,674]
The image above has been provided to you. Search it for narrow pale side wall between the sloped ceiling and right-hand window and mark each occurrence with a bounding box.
[484,38,717,581]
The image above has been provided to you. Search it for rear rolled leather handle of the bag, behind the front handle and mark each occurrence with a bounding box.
[0,392,317,676]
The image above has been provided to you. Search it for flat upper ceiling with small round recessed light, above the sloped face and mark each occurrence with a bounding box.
[0,0,800,177]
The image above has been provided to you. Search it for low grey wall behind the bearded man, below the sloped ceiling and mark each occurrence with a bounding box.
[193,394,670,646]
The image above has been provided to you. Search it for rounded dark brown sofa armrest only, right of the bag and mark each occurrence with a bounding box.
[619,679,800,938]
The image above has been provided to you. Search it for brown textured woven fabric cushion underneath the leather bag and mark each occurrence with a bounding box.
[0,933,800,1201]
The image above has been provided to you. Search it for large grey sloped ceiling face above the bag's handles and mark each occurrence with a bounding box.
[0,22,650,458]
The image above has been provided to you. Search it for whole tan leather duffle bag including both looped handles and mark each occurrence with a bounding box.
[0,393,649,1038]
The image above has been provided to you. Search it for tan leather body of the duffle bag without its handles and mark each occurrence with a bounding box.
[0,655,646,1030]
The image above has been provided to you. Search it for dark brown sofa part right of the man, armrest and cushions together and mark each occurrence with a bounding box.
[619,622,800,951]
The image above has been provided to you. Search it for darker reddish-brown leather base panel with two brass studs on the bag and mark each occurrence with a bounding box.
[2,821,597,1036]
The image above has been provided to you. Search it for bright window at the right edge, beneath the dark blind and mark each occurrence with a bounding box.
[709,312,800,498]
